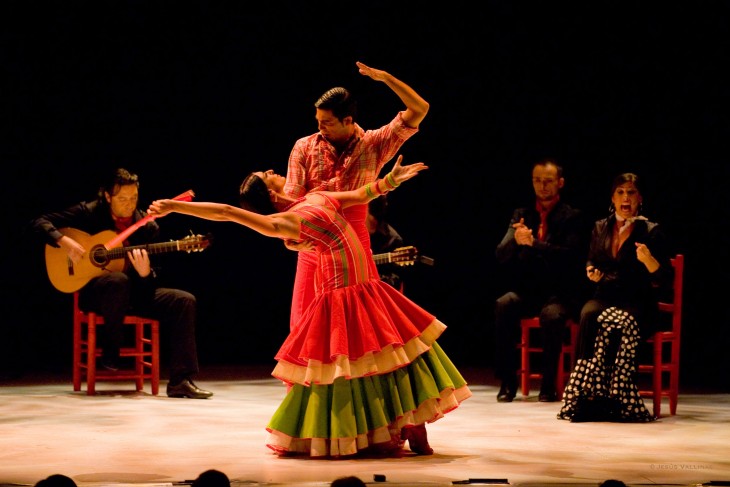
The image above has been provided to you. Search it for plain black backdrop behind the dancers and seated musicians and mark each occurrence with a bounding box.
[0,1,730,391]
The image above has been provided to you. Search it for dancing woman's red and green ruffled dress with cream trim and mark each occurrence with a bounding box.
[267,193,471,458]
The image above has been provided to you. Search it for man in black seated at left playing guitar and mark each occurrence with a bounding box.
[31,168,213,399]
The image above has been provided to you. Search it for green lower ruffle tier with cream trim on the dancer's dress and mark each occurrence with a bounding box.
[266,343,471,457]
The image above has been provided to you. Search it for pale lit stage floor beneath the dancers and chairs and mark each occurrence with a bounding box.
[0,366,730,487]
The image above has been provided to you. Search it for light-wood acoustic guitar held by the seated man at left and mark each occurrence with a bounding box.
[46,228,210,293]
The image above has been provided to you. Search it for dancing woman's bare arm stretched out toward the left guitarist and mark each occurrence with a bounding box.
[147,199,300,239]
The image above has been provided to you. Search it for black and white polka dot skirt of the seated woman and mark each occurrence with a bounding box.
[558,307,655,423]
